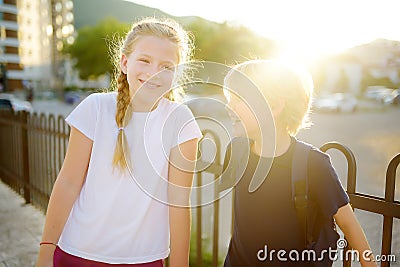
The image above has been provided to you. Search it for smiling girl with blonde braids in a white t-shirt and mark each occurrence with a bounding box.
[36,19,202,267]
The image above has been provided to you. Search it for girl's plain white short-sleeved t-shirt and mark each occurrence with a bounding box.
[59,92,202,264]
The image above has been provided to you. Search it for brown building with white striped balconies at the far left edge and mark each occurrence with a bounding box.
[0,0,24,91]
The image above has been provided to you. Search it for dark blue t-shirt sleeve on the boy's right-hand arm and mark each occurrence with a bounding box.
[308,150,350,217]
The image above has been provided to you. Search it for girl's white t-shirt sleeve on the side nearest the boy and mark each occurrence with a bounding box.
[172,105,203,147]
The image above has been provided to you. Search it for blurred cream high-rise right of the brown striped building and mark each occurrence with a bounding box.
[8,0,74,93]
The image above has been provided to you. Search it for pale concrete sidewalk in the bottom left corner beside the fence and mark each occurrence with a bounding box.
[0,181,45,267]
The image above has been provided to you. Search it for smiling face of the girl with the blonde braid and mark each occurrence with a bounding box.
[121,36,179,107]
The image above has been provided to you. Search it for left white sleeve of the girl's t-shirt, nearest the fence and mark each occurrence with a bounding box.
[65,94,98,140]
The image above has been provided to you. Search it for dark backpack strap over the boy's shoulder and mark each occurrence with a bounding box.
[292,139,312,247]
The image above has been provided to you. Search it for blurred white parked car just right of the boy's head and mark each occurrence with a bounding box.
[312,93,358,112]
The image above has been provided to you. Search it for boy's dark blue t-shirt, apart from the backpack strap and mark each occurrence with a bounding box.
[225,138,349,267]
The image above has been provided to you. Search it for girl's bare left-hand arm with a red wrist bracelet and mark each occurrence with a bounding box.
[36,127,93,267]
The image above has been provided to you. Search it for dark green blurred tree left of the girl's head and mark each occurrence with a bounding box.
[64,17,128,79]
